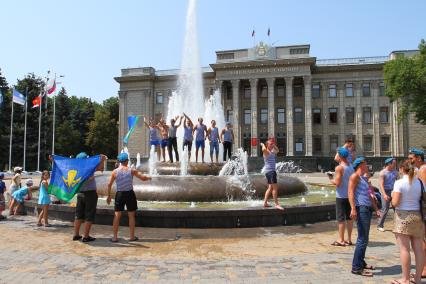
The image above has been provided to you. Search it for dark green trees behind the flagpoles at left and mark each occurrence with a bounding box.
[0,70,118,171]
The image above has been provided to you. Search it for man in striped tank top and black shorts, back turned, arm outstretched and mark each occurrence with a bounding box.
[107,153,151,243]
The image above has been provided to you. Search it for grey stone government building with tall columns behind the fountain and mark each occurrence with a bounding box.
[115,42,426,160]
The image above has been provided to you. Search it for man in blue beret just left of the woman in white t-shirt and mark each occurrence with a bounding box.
[377,157,398,232]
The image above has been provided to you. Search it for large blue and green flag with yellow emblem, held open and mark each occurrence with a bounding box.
[48,155,101,202]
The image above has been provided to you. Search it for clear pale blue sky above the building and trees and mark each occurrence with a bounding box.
[0,0,426,102]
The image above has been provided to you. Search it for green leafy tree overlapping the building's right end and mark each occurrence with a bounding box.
[384,39,426,124]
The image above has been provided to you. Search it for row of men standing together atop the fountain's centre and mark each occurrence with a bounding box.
[143,113,235,163]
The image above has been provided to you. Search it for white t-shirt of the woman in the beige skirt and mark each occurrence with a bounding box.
[393,175,422,211]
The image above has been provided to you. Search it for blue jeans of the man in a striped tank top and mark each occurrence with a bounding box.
[352,206,373,271]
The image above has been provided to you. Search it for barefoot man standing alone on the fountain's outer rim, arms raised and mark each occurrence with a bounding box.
[260,139,284,210]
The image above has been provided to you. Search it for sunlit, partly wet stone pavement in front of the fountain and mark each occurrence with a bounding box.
[0,213,414,283]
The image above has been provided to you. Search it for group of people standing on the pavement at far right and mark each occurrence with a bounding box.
[329,143,426,284]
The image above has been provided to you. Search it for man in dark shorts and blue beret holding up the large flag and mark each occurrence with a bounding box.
[72,152,106,243]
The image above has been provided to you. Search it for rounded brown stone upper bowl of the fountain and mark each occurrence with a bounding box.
[96,174,307,202]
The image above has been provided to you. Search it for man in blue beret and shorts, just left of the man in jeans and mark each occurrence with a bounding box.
[328,147,354,246]
